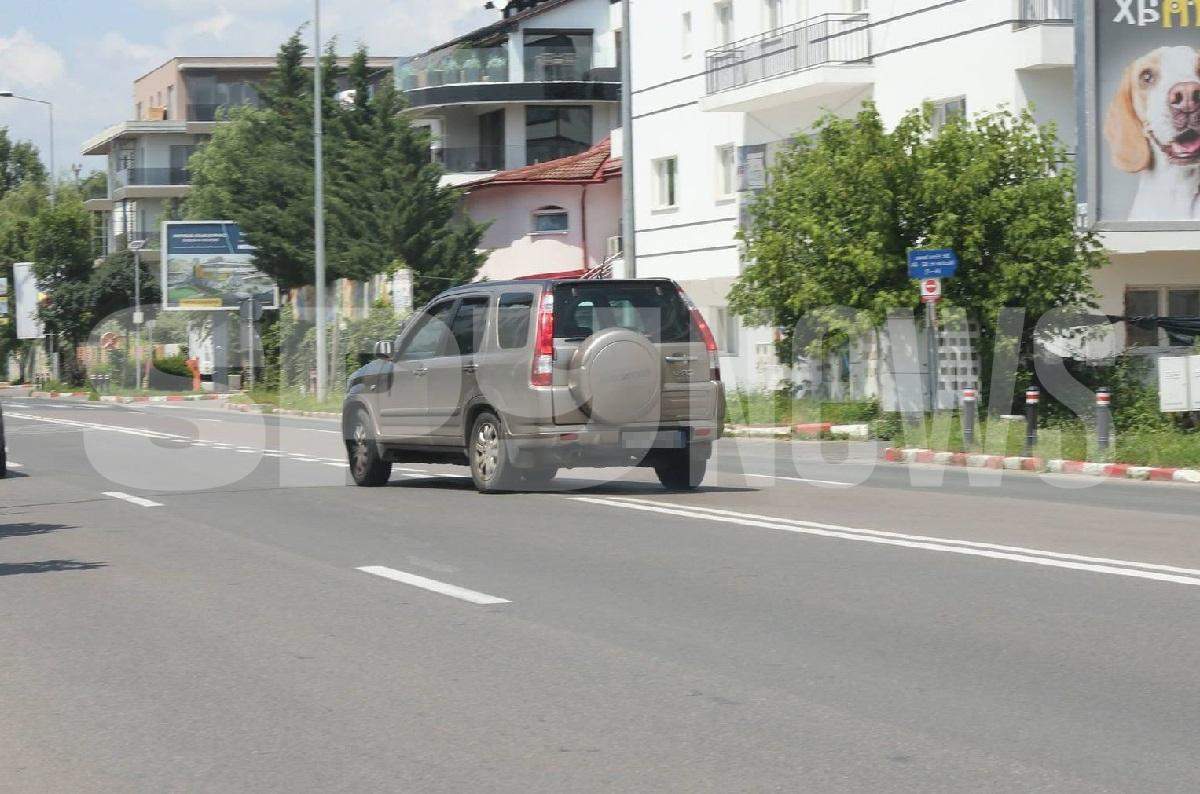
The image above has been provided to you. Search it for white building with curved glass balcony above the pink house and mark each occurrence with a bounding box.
[396,0,620,185]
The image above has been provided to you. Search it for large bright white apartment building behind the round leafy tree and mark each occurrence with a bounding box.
[626,0,1084,396]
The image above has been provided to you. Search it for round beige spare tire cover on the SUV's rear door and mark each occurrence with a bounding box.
[568,329,662,425]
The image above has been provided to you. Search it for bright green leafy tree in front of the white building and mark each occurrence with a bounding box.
[730,104,1104,395]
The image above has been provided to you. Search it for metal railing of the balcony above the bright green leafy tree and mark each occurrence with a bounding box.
[707,13,871,94]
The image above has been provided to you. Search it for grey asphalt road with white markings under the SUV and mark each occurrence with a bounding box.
[0,399,1200,792]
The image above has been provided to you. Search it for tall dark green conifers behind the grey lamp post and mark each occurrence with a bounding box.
[186,34,484,302]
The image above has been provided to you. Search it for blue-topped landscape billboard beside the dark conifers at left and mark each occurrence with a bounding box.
[162,221,280,311]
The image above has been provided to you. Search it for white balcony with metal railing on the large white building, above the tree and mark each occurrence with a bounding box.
[701,13,874,112]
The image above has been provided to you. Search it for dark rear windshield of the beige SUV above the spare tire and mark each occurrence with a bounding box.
[554,281,698,343]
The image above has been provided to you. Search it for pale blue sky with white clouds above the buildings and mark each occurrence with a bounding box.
[0,0,500,176]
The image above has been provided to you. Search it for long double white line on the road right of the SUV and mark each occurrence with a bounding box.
[574,497,1200,587]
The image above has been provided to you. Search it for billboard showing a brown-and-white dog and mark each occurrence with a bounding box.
[1076,0,1200,230]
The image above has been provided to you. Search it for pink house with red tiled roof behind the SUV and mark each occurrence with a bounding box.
[463,139,620,281]
